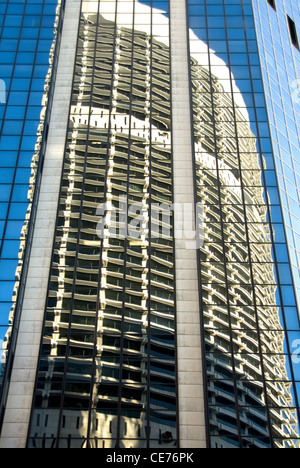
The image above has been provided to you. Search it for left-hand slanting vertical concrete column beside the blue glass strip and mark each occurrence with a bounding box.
[0,0,81,448]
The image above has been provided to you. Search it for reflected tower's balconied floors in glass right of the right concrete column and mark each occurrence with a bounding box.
[192,62,298,447]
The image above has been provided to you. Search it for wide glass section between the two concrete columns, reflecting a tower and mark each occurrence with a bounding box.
[28,0,177,448]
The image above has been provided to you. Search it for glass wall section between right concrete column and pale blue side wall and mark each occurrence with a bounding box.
[188,0,300,448]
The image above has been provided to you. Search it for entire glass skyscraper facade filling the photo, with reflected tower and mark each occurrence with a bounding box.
[0,0,300,450]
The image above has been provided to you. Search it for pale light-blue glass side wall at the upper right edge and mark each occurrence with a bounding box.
[254,0,300,314]
